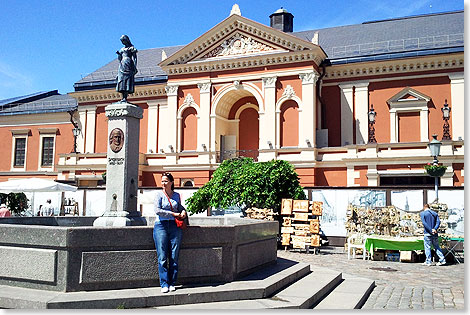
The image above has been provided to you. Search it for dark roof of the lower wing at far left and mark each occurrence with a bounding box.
[0,90,78,116]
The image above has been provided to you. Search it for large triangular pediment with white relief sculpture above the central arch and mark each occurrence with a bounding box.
[159,14,326,68]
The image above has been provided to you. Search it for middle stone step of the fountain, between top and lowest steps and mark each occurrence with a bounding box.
[157,269,342,310]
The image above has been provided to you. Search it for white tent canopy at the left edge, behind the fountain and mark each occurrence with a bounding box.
[0,178,77,194]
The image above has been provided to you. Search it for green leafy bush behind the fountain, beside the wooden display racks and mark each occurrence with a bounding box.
[186,157,307,213]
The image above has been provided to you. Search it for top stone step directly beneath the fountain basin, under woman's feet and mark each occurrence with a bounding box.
[0,259,310,309]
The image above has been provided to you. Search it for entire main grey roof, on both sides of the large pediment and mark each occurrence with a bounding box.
[74,11,464,91]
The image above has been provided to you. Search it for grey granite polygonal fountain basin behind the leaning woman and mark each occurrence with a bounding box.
[0,217,278,292]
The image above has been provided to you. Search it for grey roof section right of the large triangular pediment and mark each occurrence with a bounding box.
[292,11,464,63]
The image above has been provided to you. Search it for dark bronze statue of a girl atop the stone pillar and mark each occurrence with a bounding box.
[116,35,137,103]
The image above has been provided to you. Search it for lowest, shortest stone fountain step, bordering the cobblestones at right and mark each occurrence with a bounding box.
[313,274,375,310]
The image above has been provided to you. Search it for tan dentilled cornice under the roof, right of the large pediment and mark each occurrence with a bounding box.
[324,53,464,80]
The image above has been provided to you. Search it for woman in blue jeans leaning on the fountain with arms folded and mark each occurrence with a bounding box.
[153,173,187,293]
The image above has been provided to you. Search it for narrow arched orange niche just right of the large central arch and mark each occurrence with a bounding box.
[280,100,299,147]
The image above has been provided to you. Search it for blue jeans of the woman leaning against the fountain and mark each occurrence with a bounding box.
[153,220,183,288]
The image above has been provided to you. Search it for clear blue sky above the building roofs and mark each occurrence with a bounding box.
[0,0,464,99]
